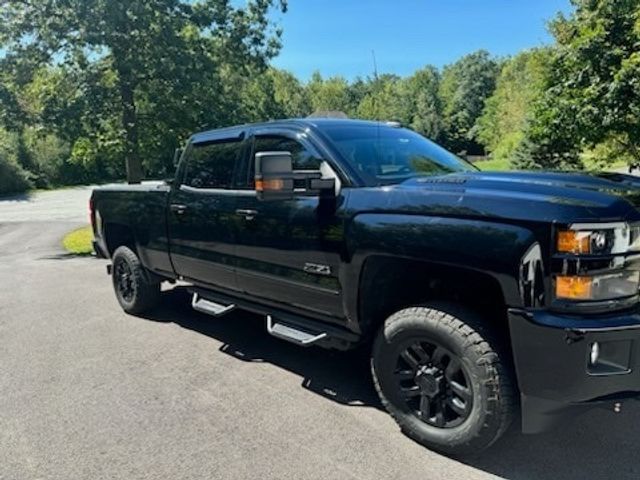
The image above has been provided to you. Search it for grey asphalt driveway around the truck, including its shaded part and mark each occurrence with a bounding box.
[0,189,640,480]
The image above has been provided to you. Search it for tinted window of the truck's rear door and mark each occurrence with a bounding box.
[183,141,242,188]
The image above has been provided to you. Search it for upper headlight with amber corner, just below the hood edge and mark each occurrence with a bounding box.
[556,223,640,255]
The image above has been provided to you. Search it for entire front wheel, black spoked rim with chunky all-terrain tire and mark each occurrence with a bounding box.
[371,303,517,456]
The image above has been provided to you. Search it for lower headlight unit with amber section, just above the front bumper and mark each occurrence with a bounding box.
[556,271,640,301]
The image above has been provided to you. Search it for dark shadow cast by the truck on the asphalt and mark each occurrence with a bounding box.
[144,287,640,480]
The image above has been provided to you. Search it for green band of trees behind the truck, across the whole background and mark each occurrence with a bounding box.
[0,0,640,192]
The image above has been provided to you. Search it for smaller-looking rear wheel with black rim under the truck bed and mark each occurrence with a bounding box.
[111,246,160,315]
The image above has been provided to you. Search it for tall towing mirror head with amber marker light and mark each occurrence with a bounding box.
[255,152,293,200]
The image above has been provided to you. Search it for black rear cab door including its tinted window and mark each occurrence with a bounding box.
[168,135,244,290]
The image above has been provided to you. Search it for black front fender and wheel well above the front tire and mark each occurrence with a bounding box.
[343,213,544,336]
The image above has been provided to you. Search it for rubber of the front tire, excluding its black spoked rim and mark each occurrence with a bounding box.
[371,302,516,455]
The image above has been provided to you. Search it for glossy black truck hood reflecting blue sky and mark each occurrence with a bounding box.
[356,172,640,223]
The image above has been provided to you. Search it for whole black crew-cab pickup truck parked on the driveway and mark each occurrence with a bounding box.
[91,119,640,454]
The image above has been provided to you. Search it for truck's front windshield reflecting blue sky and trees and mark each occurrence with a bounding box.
[322,124,476,185]
